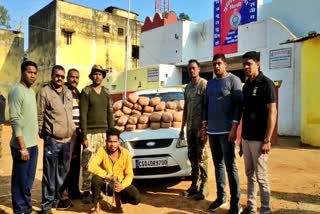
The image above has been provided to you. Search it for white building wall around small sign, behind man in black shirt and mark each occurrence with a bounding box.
[238,19,300,136]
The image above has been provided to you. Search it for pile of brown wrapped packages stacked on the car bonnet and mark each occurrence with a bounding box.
[113,93,184,131]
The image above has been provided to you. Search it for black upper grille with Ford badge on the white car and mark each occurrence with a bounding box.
[129,139,173,149]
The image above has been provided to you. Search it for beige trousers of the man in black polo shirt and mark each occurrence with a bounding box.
[242,139,271,214]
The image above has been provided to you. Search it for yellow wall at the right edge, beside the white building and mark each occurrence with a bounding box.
[301,37,320,147]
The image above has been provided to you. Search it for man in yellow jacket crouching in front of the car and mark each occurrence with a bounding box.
[88,128,140,214]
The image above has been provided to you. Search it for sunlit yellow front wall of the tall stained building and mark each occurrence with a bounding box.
[57,1,142,89]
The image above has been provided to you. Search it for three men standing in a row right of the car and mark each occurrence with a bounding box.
[180,51,277,214]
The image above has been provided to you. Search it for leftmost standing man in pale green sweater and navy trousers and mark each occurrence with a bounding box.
[9,61,38,214]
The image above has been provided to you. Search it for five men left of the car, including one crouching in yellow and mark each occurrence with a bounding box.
[8,61,140,214]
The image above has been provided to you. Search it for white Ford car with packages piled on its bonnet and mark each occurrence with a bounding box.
[120,88,191,179]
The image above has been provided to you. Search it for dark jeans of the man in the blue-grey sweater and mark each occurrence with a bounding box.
[209,134,240,207]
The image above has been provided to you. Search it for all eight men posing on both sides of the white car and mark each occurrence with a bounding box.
[4,49,276,214]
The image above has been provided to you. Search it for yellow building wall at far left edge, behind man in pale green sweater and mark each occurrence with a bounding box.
[0,29,24,120]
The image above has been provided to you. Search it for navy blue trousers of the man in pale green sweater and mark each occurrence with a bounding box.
[11,146,38,214]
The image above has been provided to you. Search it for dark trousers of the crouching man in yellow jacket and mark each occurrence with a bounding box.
[91,175,140,205]
